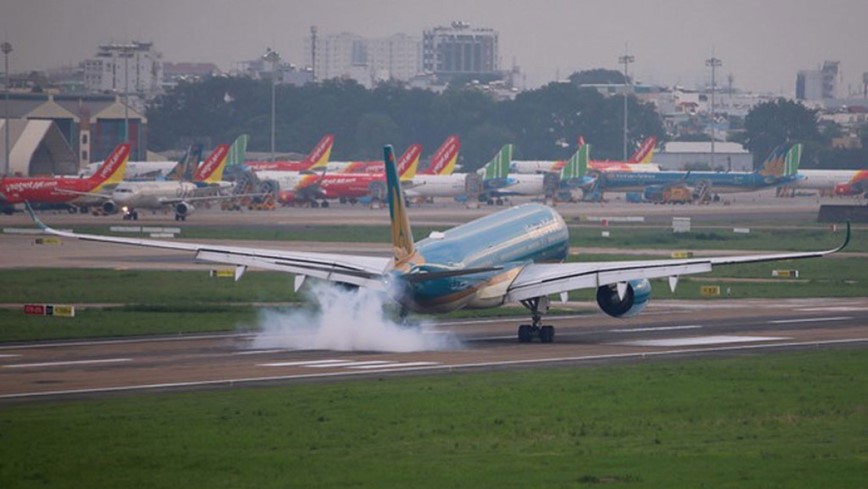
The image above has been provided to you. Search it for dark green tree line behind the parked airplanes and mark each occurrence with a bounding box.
[147,70,868,170]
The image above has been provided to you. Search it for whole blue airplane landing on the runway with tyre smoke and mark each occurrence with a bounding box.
[27,146,850,343]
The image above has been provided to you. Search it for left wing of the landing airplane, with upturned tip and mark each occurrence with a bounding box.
[26,204,392,290]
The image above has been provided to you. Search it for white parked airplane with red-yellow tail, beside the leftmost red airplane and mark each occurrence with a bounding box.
[102,144,232,217]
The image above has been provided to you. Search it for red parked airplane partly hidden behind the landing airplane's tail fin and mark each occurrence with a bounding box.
[278,144,422,207]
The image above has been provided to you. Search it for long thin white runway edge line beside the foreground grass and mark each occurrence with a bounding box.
[0,337,868,399]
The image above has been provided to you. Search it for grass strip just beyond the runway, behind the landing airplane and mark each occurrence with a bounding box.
[0,246,868,341]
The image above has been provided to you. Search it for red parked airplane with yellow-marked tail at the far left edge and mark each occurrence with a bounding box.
[0,143,130,214]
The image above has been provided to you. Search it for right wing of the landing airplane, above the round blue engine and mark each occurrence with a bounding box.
[507,222,850,302]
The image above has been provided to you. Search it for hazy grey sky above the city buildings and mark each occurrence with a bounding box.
[0,0,868,95]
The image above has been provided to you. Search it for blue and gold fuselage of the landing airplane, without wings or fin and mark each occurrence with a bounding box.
[393,204,569,312]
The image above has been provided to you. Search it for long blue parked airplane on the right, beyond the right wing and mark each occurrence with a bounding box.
[591,144,802,200]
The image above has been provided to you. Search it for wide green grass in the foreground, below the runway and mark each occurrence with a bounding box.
[0,350,868,489]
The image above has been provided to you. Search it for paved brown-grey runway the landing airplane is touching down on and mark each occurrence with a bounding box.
[0,298,868,403]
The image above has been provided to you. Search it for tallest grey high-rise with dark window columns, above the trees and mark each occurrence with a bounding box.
[422,22,500,78]
